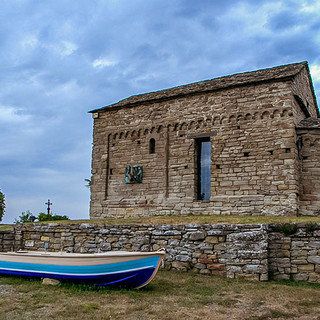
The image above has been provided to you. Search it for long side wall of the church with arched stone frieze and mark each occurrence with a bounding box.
[90,81,299,218]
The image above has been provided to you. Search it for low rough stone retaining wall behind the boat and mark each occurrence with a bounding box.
[0,223,320,282]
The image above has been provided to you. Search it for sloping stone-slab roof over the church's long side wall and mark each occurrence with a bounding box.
[90,61,308,112]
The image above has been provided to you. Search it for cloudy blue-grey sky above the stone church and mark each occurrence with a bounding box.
[0,0,320,223]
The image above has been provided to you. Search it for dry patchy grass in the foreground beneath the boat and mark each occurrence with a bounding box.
[0,270,320,320]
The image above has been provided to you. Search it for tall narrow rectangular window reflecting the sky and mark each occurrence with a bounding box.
[196,137,211,200]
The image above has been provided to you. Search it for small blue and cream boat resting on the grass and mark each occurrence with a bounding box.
[0,251,164,288]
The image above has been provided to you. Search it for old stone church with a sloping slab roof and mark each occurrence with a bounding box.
[90,62,320,218]
